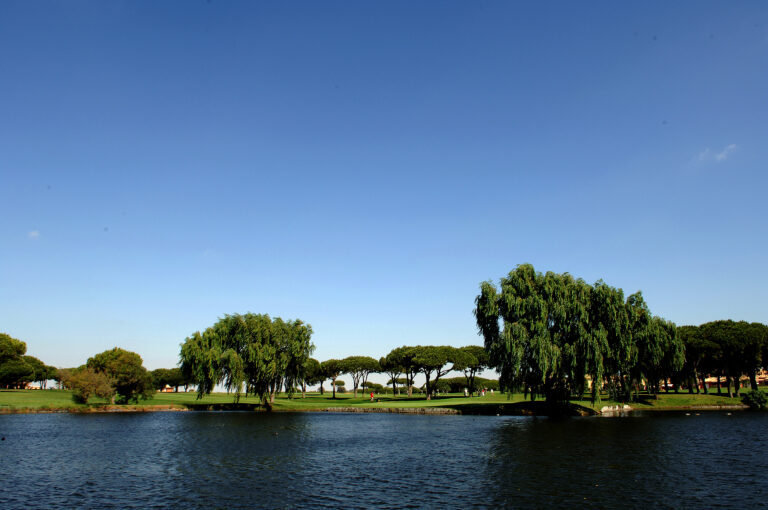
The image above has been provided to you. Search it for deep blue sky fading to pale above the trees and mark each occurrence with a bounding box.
[0,0,768,369]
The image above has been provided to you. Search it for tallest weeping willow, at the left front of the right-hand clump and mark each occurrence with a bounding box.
[475,264,609,403]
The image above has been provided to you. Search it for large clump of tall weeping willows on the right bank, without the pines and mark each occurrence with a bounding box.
[475,264,685,402]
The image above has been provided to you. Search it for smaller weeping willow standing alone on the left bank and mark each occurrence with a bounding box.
[180,313,314,404]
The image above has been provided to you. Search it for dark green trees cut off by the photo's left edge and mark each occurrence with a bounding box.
[0,333,57,388]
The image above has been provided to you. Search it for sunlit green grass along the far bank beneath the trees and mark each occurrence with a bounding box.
[0,390,756,412]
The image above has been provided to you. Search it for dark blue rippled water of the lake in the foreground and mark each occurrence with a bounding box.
[0,412,768,509]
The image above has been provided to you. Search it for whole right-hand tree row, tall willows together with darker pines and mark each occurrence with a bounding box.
[475,264,768,402]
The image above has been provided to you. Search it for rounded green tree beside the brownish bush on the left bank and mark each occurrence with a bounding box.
[86,347,152,403]
